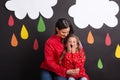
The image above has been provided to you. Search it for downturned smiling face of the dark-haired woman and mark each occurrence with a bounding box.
[56,27,70,38]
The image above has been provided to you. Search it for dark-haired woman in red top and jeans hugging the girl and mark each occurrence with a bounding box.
[40,18,79,80]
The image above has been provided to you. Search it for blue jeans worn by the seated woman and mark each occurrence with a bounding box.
[40,69,67,80]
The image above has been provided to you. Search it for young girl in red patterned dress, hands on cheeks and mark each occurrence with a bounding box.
[60,34,89,80]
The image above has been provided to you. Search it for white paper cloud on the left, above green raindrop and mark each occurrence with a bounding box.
[5,0,57,19]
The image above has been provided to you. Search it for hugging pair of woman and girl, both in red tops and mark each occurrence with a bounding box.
[40,18,89,80]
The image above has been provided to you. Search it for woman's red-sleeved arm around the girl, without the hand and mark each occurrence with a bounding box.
[44,42,66,76]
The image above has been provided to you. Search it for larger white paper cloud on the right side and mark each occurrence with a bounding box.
[68,0,119,29]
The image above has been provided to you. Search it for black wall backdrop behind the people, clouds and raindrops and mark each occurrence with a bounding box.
[0,0,120,80]
